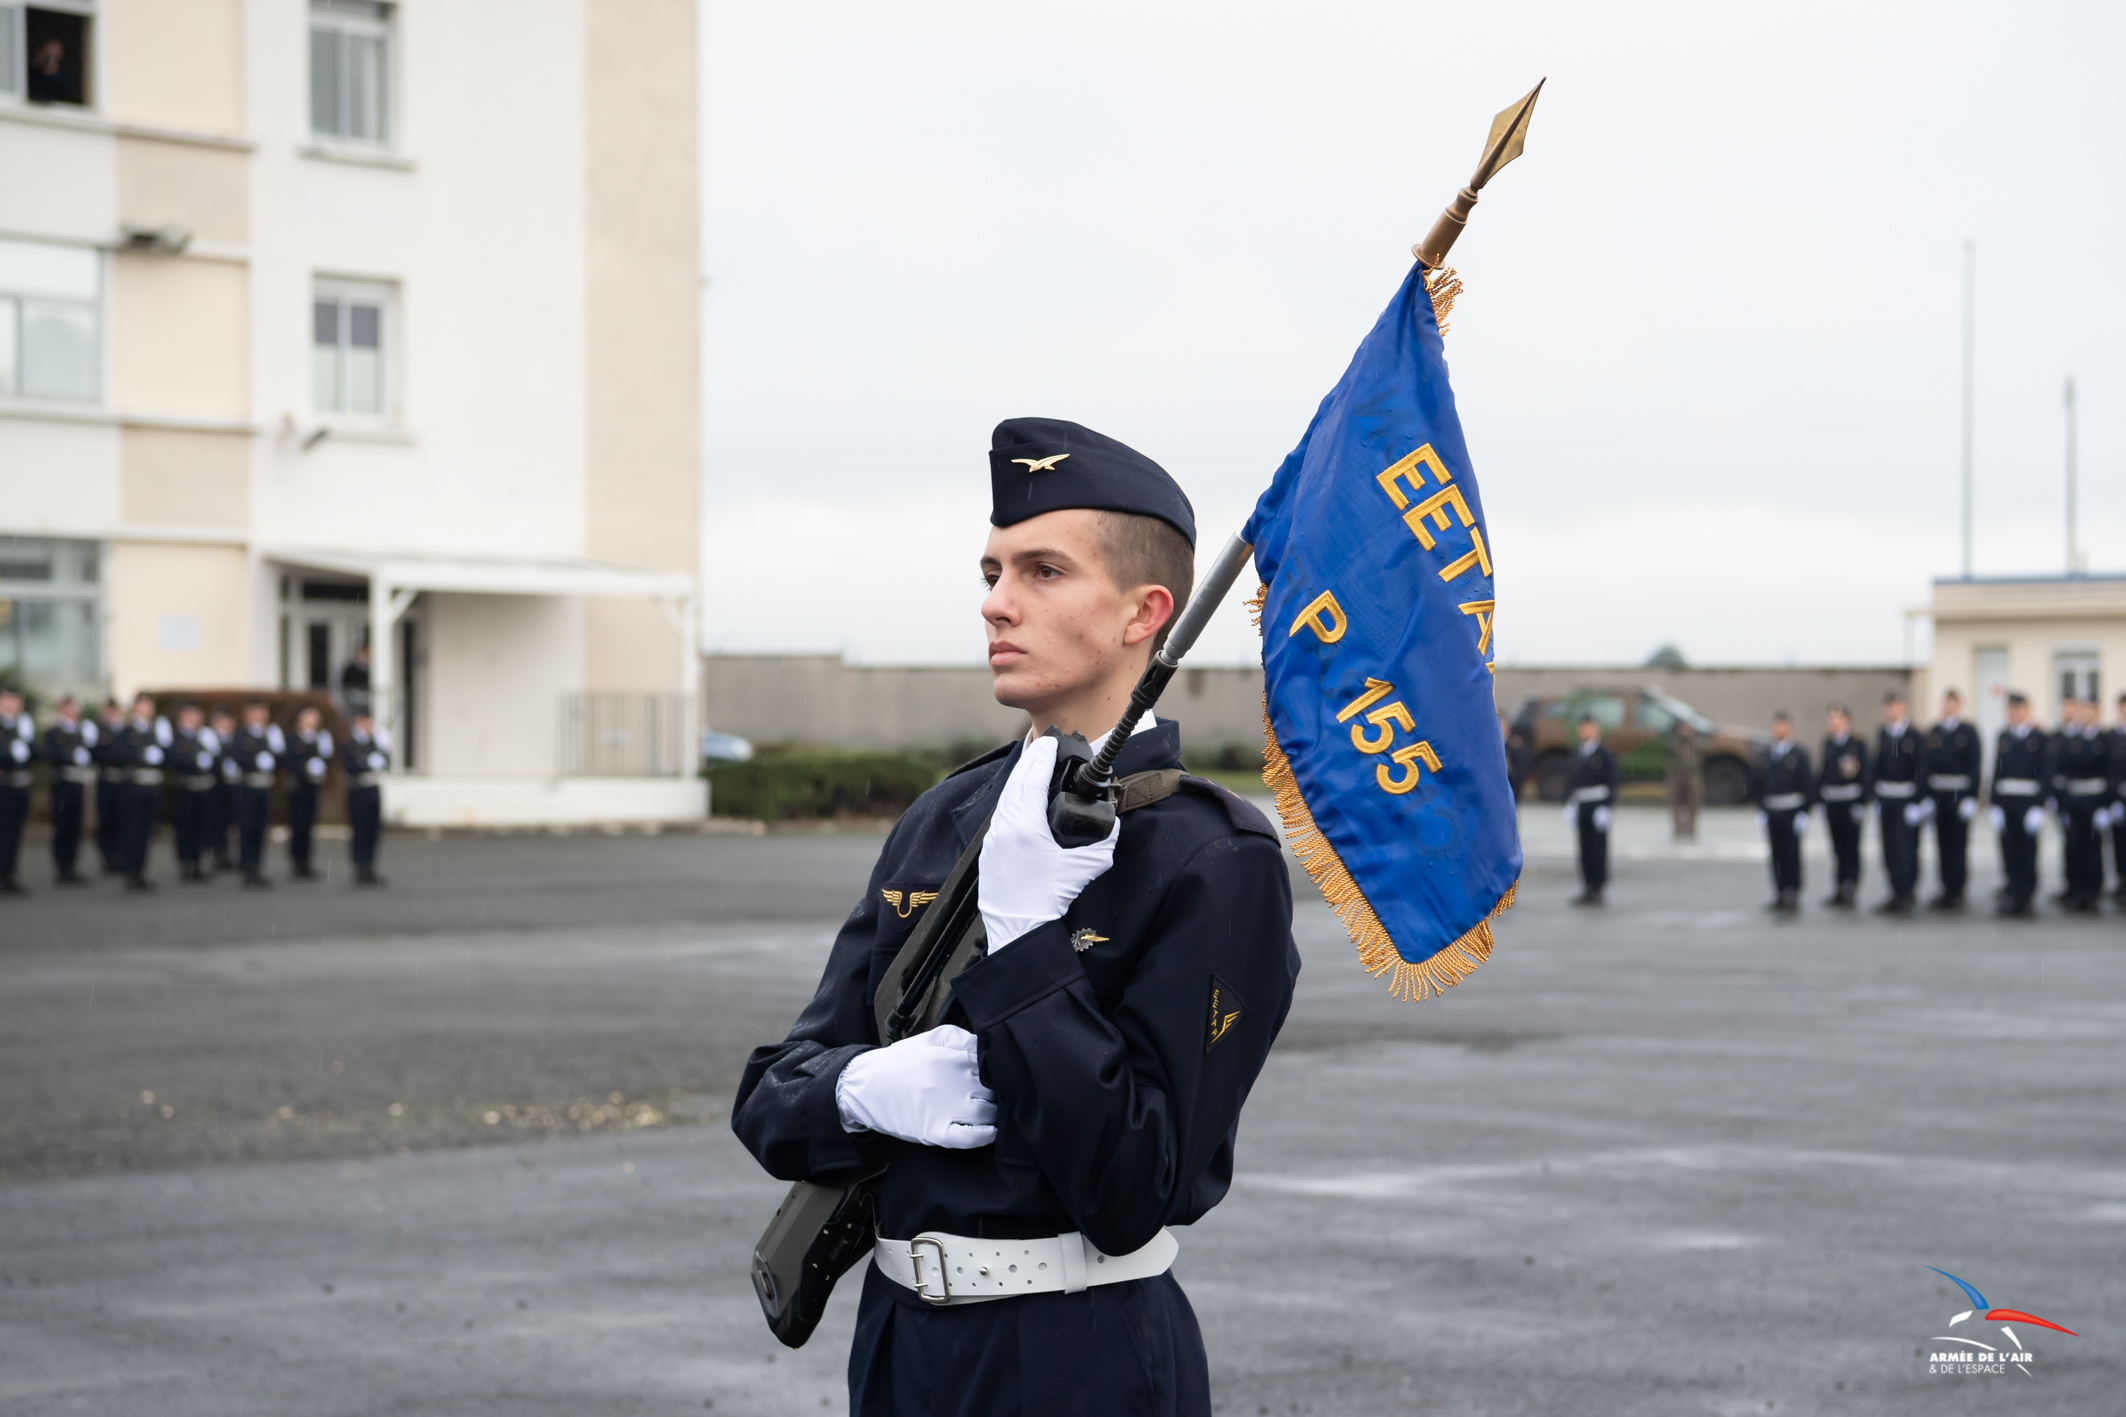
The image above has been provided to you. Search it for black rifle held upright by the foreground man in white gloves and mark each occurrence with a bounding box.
[753,535,1254,1349]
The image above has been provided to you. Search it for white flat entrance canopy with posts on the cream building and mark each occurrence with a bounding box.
[259,546,699,775]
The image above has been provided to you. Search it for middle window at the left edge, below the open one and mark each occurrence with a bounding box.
[0,238,102,399]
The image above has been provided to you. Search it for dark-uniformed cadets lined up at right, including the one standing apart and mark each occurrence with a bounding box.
[1565,688,2126,916]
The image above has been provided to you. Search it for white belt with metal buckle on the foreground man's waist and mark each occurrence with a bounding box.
[872,1228,1182,1304]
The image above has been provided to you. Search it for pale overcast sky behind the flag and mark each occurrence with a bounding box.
[702,0,2126,665]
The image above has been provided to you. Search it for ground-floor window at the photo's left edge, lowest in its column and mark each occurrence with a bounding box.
[0,535,102,699]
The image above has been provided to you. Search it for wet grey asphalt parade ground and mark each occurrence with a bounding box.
[0,809,2126,1417]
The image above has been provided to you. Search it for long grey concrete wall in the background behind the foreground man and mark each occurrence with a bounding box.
[702,654,1911,750]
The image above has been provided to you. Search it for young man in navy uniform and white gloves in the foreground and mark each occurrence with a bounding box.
[731,419,1299,1417]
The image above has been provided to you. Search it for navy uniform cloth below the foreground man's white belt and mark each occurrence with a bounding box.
[848,1264,1210,1417]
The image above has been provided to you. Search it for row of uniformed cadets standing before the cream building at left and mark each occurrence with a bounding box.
[0,688,391,894]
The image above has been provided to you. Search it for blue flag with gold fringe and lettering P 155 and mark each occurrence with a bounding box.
[1242,266,1520,998]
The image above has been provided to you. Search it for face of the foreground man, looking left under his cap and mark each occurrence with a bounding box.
[982,508,1174,733]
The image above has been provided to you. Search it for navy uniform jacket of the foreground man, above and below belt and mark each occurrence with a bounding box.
[731,722,1299,1413]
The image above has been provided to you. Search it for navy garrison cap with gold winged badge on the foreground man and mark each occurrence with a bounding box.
[989,419,1195,546]
